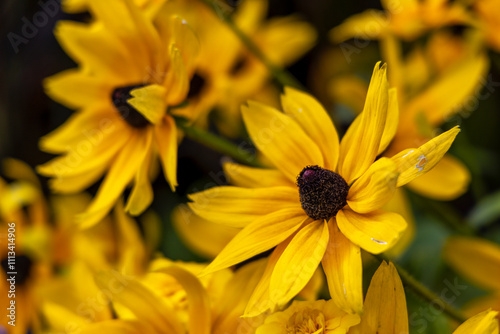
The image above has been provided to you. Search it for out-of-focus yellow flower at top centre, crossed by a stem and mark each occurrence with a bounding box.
[160,0,316,137]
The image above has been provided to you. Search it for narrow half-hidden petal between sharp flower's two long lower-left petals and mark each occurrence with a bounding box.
[243,236,293,317]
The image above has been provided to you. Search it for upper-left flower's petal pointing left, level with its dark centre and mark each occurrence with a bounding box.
[43,69,111,109]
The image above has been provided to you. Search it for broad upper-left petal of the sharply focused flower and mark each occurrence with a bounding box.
[242,101,323,182]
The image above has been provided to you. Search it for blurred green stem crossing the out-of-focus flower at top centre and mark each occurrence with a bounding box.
[201,0,306,91]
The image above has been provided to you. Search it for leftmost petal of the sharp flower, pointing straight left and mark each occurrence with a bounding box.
[189,186,304,228]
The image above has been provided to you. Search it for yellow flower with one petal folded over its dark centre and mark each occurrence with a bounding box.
[38,0,198,226]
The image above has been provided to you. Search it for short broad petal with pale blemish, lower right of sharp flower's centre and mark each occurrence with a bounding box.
[337,209,406,254]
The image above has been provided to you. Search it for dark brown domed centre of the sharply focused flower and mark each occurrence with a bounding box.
[297,166,349,219]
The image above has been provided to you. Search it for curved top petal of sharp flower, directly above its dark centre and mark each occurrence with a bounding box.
[281,87,339,170]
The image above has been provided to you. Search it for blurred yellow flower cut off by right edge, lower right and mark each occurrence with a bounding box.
[443,237,500,316]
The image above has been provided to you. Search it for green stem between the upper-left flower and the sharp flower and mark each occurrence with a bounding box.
[175,118,262,167]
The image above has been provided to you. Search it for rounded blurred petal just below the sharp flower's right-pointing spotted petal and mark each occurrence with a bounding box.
[407,154,470,201]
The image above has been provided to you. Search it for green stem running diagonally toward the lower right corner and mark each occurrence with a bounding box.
[373,254,467,323]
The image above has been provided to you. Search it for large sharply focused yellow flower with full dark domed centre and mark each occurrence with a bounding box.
[190,64,459,316]
